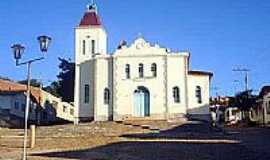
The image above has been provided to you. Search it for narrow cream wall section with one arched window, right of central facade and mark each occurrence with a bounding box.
[167,55,187,117]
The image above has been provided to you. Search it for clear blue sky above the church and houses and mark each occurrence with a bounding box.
[0,0,270,94]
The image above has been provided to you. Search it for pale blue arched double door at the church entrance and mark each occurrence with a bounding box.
[133,87,150,117]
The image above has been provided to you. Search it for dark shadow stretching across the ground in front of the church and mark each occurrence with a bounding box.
[29,123,263,160]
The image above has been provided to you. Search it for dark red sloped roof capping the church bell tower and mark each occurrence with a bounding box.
[79,12,101,26]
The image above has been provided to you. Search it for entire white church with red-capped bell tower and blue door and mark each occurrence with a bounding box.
[74,5,212,122]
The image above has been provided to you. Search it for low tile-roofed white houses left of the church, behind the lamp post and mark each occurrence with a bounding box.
[0,79,74,126]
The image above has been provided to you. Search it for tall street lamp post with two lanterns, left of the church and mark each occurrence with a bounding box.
[11,36,51,160]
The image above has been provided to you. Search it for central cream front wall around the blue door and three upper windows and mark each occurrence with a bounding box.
[114,55,166,120]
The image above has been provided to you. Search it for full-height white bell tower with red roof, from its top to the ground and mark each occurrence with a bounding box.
[74,2,107,123]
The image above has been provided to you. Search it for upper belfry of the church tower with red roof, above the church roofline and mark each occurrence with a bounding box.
[75,2,107,64]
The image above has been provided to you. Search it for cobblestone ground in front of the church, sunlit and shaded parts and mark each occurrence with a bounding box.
[0,121,270,160]
